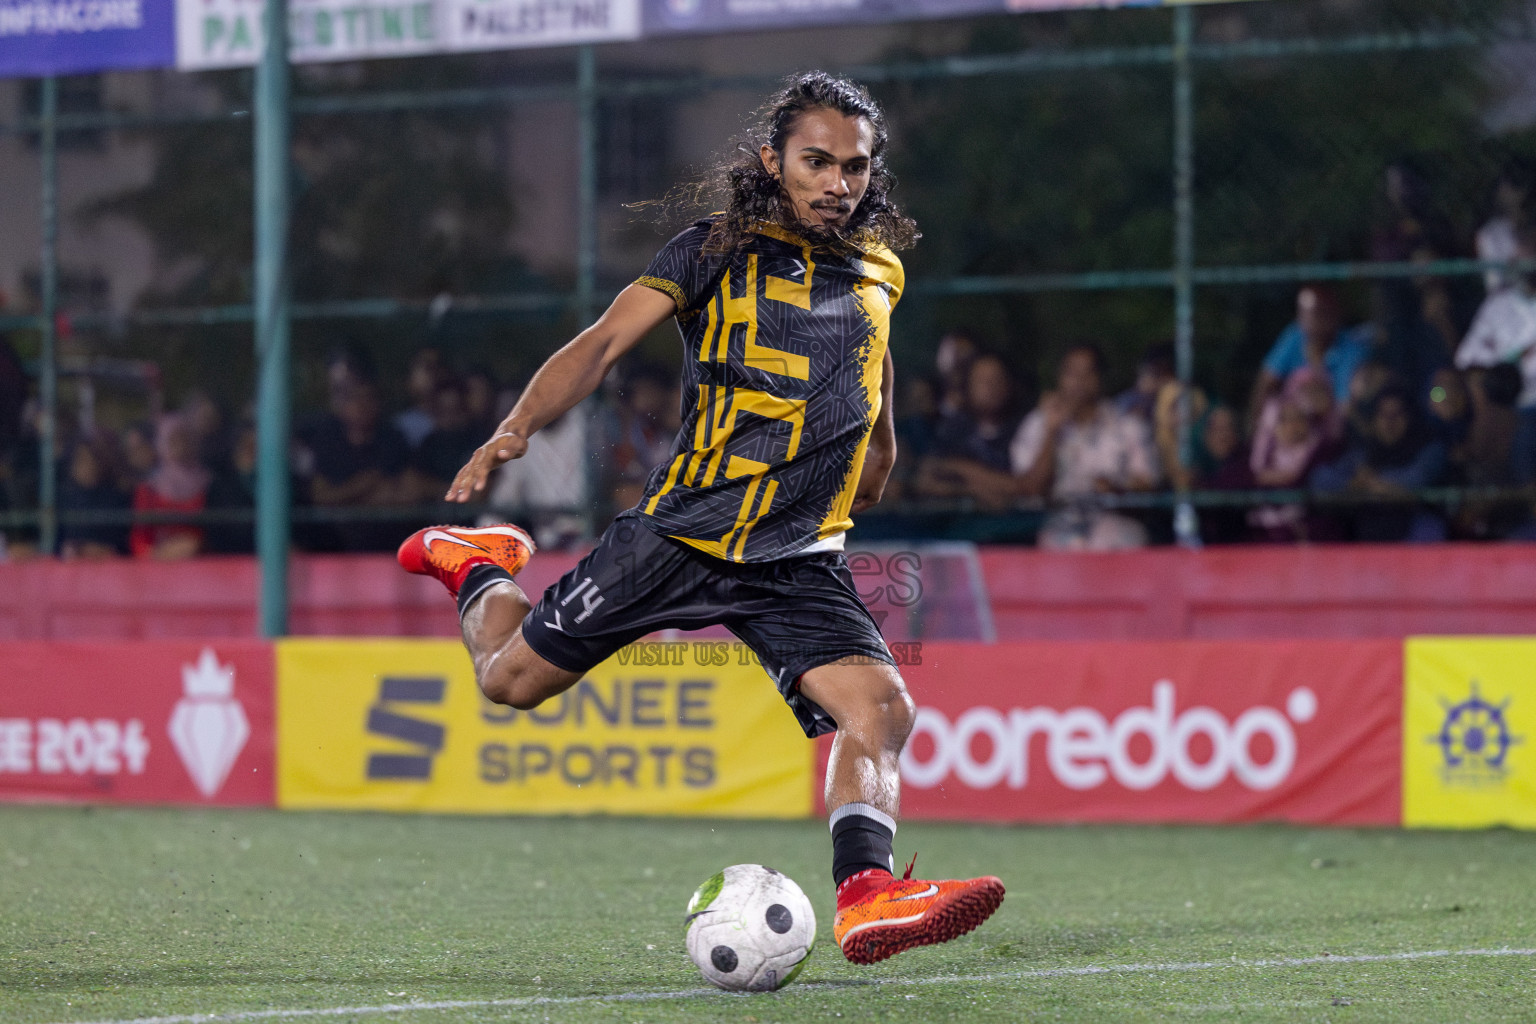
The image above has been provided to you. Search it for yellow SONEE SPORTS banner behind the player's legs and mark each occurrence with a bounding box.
[276,639,814,818]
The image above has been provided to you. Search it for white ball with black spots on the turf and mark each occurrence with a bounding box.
[688,864,816,992]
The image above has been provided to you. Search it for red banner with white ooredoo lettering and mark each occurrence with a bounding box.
[822,640,1402,824]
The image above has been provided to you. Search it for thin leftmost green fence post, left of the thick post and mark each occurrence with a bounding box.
[37,75,58,554]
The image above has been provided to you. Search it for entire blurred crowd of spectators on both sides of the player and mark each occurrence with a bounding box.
[9,164,1536,559]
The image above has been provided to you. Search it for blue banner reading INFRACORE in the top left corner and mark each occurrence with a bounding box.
[0,0,175,78]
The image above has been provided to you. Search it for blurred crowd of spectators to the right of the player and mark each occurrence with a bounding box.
[897,164,1536,550]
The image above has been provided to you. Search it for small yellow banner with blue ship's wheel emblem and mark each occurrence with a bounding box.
[1402,639,1536,827]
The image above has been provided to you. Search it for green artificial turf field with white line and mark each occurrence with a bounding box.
[0,808,1536,1024]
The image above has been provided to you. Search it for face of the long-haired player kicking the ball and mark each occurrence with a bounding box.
[762,107,874,236]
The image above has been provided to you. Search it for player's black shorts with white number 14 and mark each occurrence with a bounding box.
[522,516,895,735]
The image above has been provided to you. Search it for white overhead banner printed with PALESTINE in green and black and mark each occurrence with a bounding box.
[176,0,641,71]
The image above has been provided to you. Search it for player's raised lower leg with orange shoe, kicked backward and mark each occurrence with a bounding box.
[396,524,581,708]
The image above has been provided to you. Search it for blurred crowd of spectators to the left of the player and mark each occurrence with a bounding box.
[0,345,679,559]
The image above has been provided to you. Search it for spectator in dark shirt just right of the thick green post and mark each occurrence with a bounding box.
[307,381,410,551]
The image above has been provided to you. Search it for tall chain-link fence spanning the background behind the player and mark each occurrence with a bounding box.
[0,0,1536,592]
